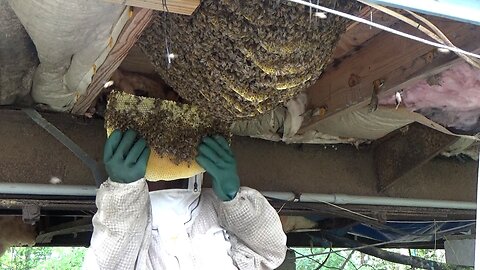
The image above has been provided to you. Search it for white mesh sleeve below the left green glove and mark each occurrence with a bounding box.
[83,179,151,270]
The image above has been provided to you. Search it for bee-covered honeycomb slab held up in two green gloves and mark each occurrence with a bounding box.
[105,91,230,181]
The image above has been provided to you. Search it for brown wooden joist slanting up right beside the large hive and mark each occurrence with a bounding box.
[299,18,480,134]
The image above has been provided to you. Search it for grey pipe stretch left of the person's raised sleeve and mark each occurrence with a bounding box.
[0,183,97,197]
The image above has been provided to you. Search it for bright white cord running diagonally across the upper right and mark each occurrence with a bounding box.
[287,0,480,59]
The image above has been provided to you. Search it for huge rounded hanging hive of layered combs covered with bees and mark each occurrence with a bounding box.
[139,0,358,121]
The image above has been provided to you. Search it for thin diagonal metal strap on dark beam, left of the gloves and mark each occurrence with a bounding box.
[22,108,106,187]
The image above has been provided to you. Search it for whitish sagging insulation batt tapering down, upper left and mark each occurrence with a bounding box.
[8,0,125,111]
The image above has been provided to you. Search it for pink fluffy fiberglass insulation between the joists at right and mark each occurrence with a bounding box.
[380,63,480,134]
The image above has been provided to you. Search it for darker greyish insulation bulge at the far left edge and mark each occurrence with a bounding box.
[0,0,38,105]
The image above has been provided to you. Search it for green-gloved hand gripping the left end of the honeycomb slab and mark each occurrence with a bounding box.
[103,129,150,183]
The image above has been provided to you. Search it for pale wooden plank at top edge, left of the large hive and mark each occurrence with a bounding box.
[104,0,200,15]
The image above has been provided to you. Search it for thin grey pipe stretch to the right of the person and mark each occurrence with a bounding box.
[262,192,476,210]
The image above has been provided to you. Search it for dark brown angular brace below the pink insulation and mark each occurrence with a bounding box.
[374,123,458,192]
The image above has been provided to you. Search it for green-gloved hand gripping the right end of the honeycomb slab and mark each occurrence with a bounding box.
[196,136,240,201]
